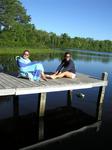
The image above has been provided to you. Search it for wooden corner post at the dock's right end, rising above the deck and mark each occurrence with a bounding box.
[96,72,108,131]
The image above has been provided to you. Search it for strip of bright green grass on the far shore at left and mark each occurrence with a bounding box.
[0,47,63,55]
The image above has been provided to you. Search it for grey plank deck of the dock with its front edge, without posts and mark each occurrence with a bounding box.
[0,73,107,96]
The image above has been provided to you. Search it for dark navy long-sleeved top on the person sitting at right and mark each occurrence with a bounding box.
[56,60,76,73]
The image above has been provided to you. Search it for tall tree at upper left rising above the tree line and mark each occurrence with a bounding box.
[0,0,30,30]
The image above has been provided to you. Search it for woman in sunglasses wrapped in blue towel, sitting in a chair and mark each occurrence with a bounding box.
[16,50,46,81]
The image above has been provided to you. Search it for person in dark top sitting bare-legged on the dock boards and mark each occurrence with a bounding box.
[50,52,76,79]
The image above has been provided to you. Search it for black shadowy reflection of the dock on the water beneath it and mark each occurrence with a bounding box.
[0,97,100,150]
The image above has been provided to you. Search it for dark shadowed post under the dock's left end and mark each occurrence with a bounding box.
[13,96,19,117]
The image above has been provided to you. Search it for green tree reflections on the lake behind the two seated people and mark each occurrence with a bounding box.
[0,52,112,72]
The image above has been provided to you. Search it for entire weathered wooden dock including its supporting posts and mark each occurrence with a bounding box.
[0,72,108,149]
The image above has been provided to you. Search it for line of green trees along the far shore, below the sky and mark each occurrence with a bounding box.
[0,0,112,52]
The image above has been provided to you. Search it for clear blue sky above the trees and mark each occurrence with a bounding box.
[21,0,112,40]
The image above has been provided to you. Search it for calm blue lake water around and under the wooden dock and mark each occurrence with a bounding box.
[0,52,112,149]
